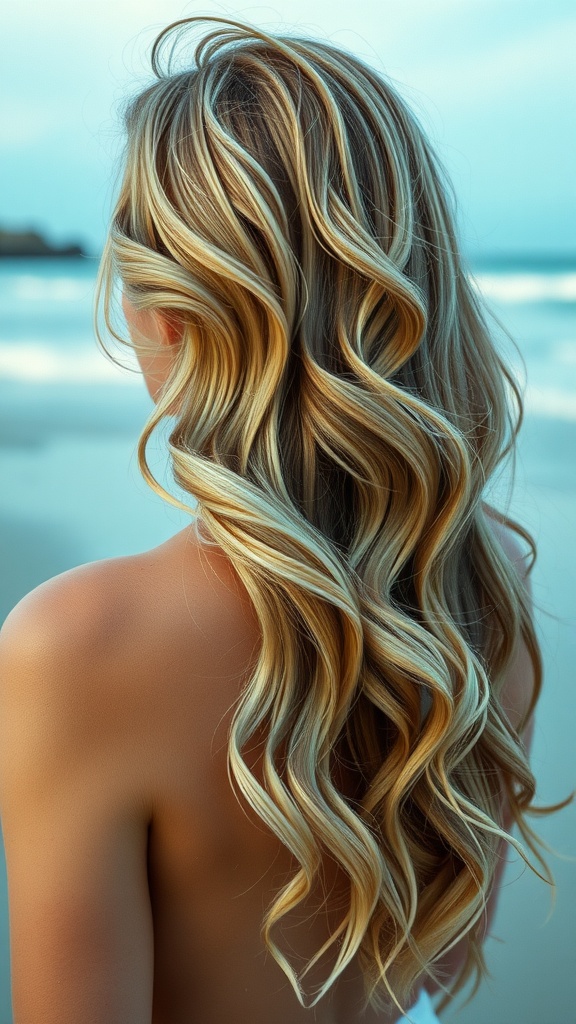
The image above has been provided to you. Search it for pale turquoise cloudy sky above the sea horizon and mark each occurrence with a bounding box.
[0,0,576,253]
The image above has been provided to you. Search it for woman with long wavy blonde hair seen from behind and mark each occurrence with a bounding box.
[0,17,565,1024]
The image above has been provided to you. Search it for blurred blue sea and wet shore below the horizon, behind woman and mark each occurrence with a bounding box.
[0,260,576,1024]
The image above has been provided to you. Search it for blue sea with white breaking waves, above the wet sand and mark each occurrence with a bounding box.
[0,259,576,420]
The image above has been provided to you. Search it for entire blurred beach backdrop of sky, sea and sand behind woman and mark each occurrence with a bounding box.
[0,0,576,1024]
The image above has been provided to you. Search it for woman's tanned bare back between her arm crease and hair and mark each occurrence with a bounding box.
[115,529,426,1024]
